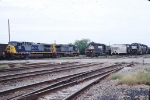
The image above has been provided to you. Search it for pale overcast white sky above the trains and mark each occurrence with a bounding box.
[0,0,150,46]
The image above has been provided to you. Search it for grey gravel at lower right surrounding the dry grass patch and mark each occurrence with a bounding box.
[77,63,150,100]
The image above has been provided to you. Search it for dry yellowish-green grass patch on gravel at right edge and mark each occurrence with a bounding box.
[110,69,150,85]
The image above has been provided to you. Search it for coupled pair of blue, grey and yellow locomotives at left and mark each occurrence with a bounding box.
[2,41,79,59]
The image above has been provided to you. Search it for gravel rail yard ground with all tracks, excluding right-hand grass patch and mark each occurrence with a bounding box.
[0,55,150,100]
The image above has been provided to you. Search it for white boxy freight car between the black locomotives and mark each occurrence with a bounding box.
[110,44,130,55]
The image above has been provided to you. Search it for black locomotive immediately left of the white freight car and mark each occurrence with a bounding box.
[85,42,110,57]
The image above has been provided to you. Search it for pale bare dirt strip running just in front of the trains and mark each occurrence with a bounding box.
[0,55,150,63]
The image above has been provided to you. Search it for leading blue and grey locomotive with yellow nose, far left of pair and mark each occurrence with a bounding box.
[5,41,52,59]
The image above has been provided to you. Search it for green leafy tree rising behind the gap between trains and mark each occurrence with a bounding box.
[74,39,90,54]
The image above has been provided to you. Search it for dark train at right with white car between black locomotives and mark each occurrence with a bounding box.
[85,42,150,57]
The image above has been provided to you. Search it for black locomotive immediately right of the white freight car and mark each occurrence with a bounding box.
[130,43,143,55]
